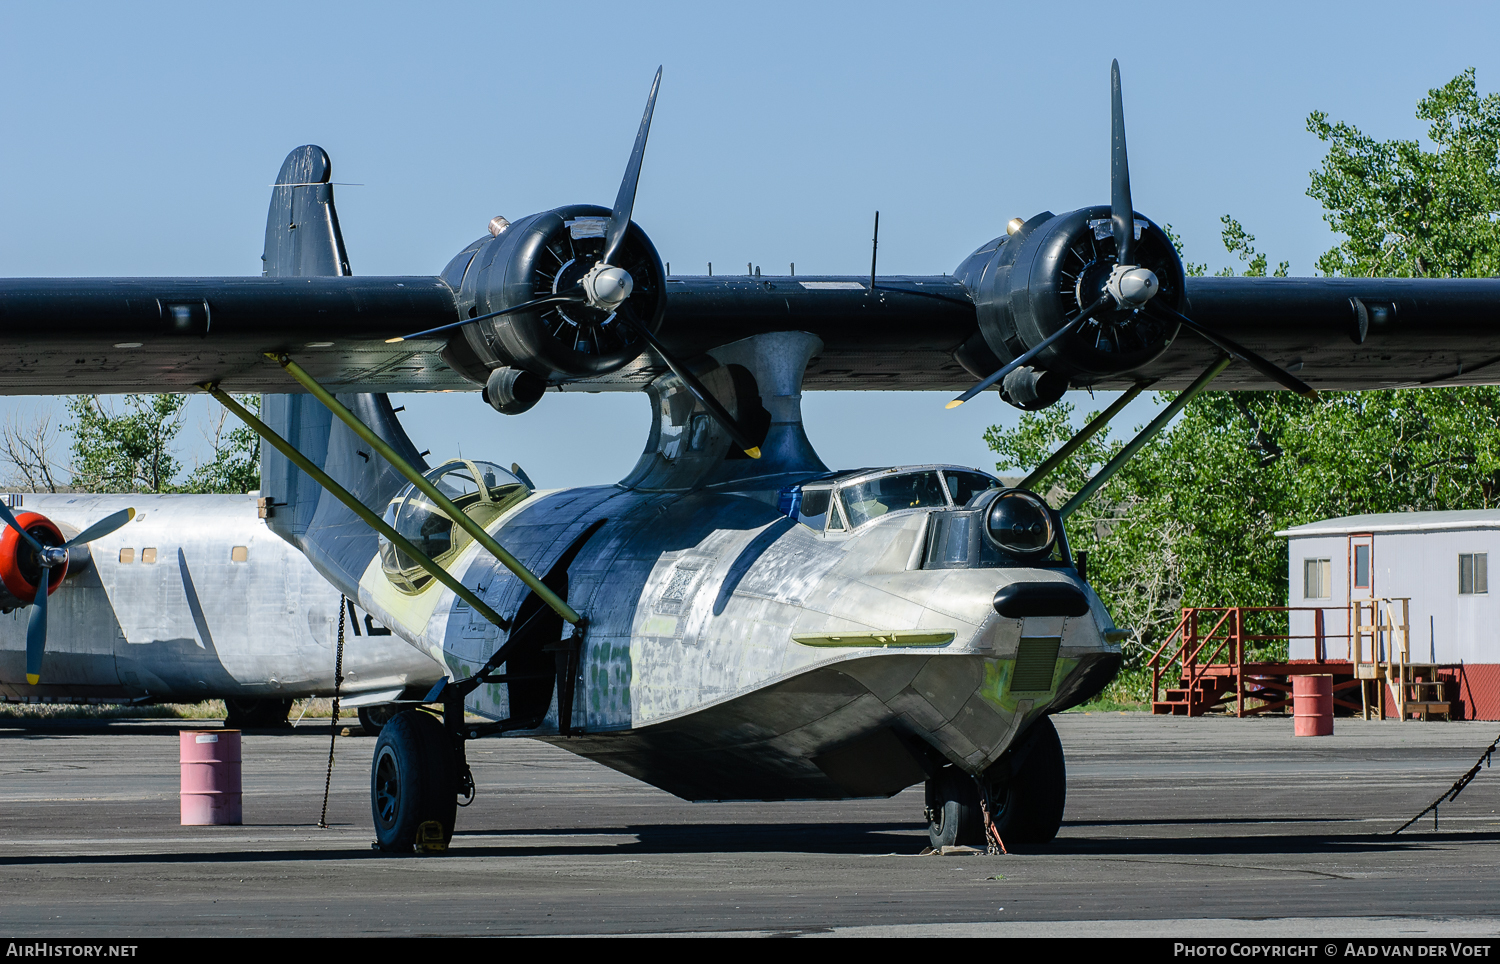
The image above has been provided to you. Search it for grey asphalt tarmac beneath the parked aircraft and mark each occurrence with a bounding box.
[0,714,1500,939]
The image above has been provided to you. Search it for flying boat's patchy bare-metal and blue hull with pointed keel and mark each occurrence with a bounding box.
[360,486,1119,799]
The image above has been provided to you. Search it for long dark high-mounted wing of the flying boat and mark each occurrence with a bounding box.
[0,276,1500,394]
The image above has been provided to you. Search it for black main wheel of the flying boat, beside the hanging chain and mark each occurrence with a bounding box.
[371,709,458,853]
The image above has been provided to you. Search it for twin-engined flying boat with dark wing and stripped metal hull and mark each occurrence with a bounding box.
[0,64,1500,850]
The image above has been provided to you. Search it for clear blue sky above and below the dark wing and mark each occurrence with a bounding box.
[0,1,1500,486]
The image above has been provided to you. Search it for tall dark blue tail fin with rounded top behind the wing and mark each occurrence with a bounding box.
[261,144,426,598]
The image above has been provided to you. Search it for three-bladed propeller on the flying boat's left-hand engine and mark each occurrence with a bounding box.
[386,67,761,459]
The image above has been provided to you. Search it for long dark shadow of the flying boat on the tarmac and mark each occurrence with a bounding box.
[0,823,1500,867]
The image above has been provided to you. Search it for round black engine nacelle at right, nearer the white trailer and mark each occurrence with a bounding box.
[954,205,1187,408]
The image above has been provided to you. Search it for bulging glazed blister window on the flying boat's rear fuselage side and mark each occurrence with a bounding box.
[380,460,531,592]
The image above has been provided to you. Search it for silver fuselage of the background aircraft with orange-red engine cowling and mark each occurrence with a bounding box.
[0,495,443,703]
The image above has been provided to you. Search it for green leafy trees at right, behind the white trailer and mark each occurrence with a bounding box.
[986,70,1500,699]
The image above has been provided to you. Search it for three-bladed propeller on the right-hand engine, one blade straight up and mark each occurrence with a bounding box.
[948,60,1317,408]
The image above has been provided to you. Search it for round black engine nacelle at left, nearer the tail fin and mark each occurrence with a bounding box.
[443,204,666,385]
